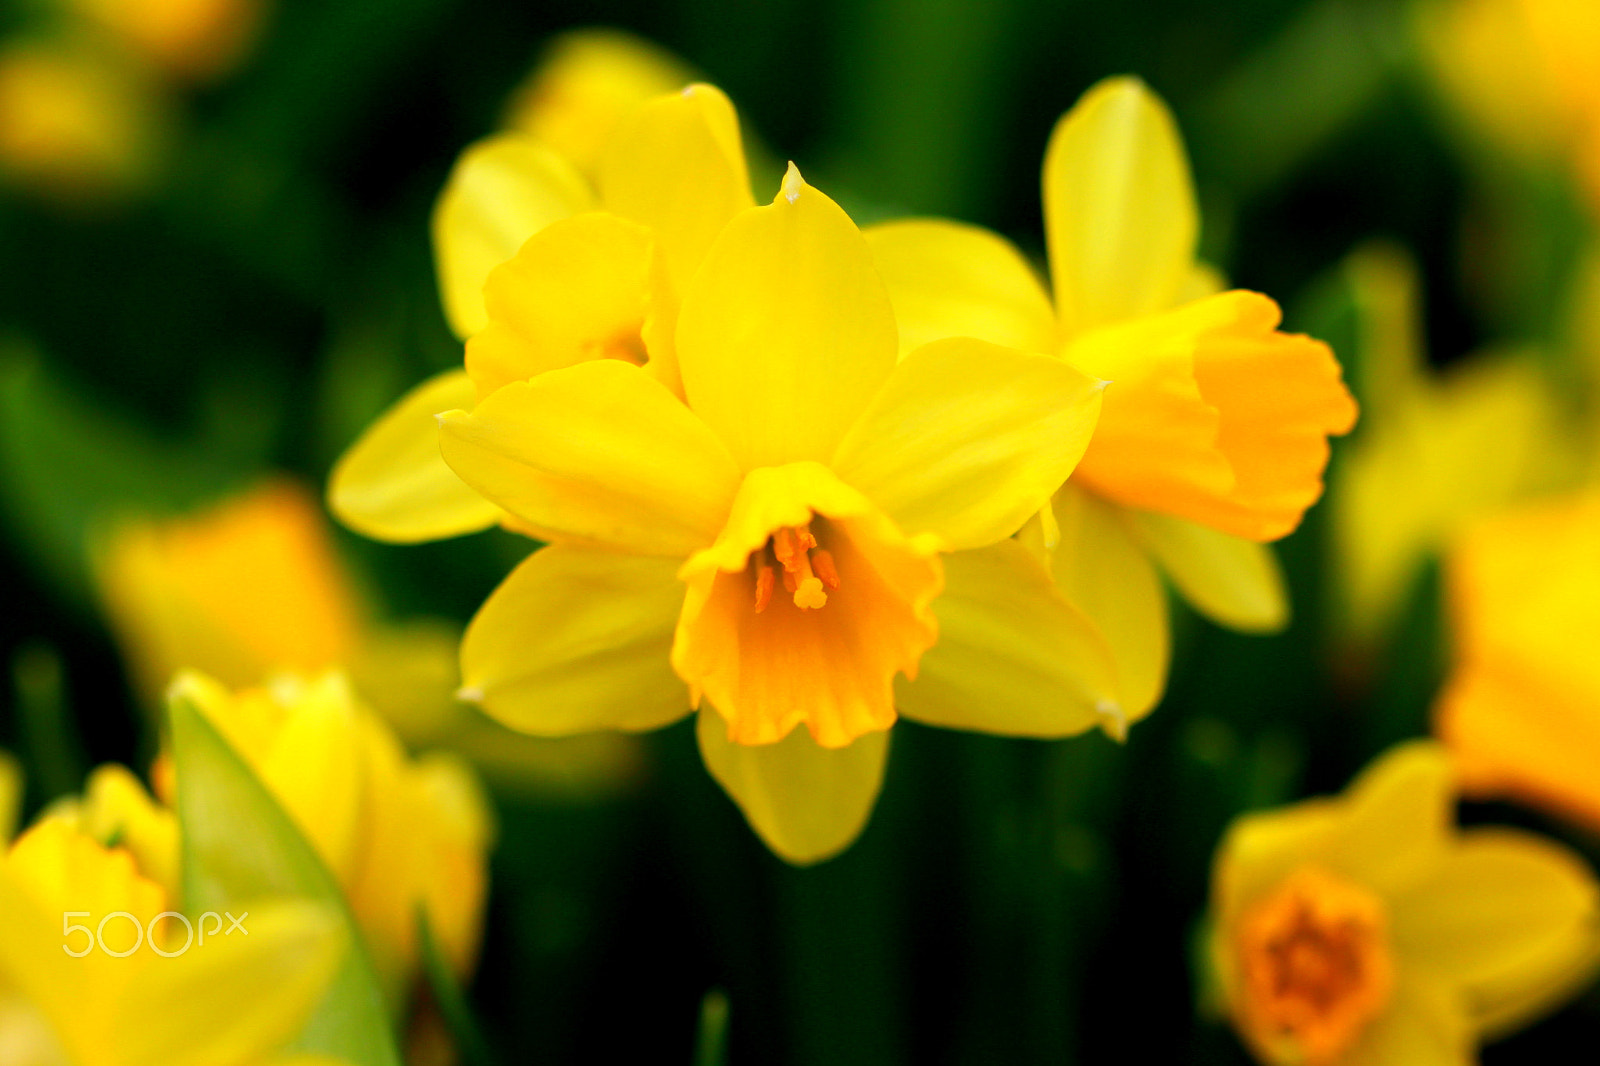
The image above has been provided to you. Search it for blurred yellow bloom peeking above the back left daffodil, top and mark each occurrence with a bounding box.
[506,29,694,179]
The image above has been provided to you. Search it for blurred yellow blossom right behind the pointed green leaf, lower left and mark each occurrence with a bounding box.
[157,672,494,1002]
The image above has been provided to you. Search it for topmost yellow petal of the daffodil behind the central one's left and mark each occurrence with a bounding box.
[598,83,755,293]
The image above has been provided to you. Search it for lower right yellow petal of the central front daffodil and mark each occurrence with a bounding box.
[894,541,1118,736]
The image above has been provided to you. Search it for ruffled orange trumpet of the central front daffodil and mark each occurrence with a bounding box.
[672,463,944,747]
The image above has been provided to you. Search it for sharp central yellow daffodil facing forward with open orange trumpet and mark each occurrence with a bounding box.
[442,166,1104,861]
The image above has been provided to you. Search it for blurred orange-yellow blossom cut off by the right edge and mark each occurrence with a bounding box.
[1435,490,1600,831]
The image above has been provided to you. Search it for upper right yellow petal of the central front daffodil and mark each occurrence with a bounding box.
[832,338,1104,549]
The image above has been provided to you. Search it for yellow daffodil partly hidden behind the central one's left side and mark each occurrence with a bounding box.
[328,85,755,543]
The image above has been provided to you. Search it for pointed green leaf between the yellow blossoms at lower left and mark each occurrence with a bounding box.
[168,690,400,1066]
